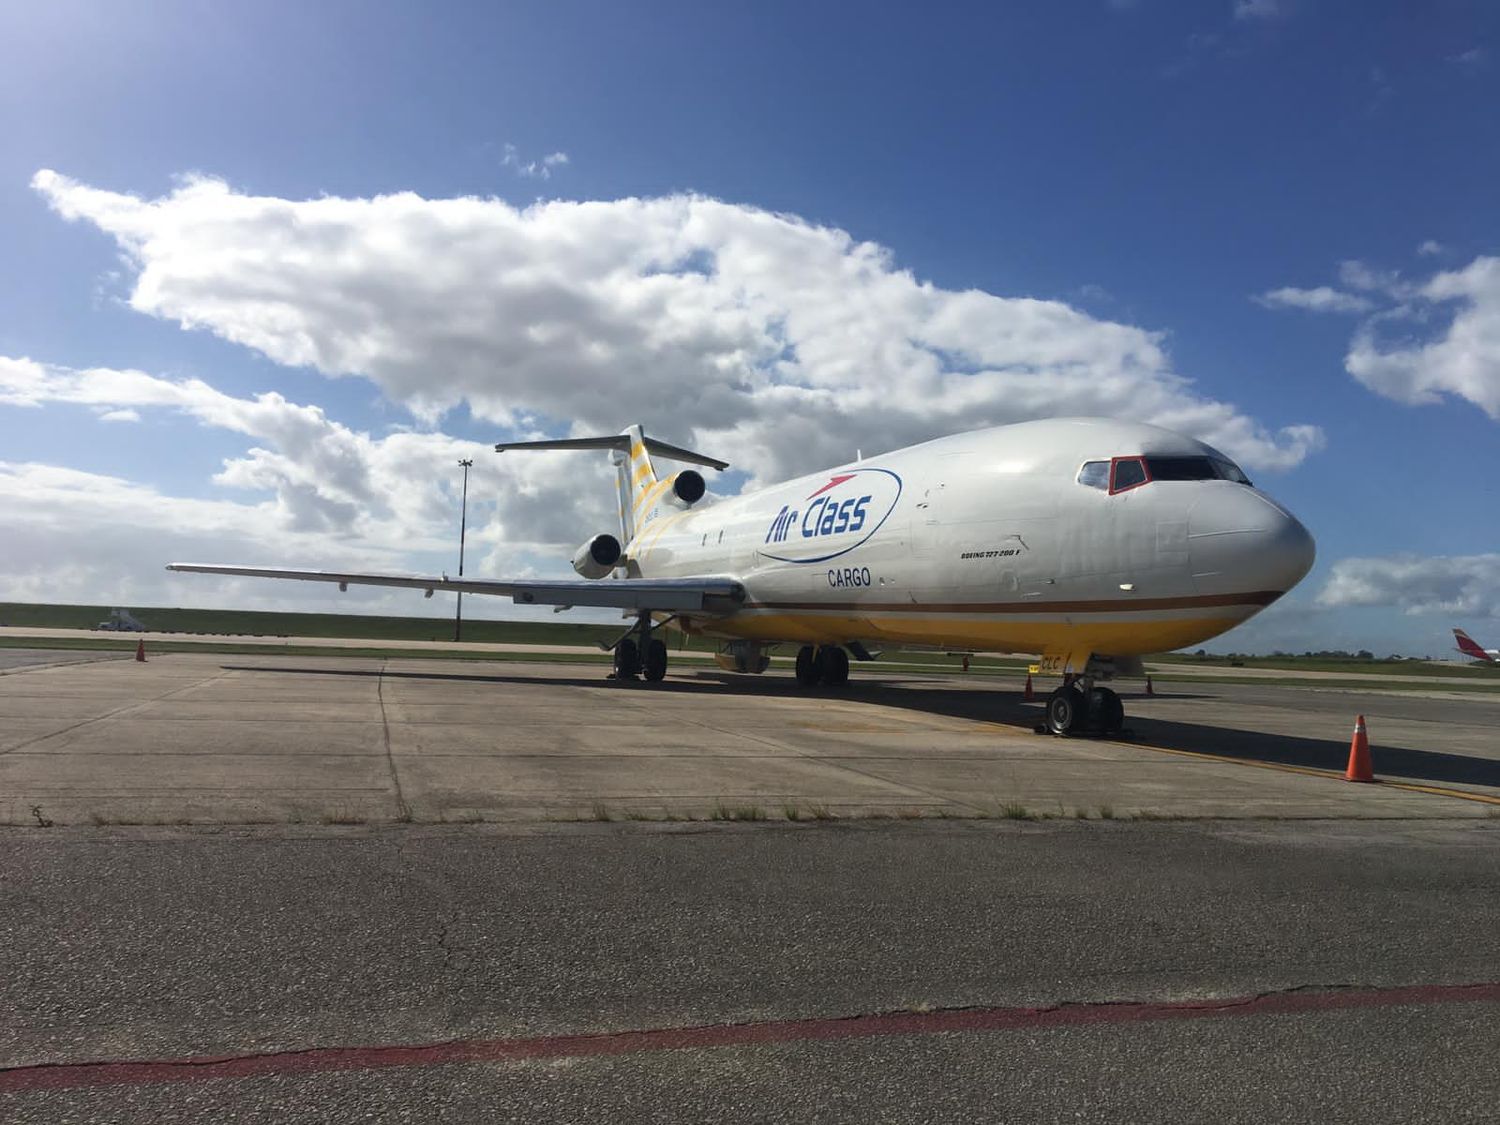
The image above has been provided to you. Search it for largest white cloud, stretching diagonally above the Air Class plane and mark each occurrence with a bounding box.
[33,171,1322,477]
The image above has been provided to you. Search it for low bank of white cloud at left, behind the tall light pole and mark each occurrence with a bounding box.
[0,357,614,600]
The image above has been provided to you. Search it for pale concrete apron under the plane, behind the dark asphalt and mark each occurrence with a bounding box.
[0,653,1500,825]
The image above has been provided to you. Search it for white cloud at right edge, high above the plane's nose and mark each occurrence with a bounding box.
[1257,255,1500,422]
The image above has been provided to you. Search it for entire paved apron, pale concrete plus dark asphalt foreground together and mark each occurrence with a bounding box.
[0,653,1500,1125]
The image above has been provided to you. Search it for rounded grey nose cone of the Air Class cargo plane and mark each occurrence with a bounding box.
[1188,486,1317,594]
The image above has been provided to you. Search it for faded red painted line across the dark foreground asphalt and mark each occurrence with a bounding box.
[0,983,1500,1092]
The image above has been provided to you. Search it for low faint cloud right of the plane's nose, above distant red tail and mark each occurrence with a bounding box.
[1317,555,1500,624]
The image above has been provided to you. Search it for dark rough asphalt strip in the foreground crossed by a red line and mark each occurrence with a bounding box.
[0,821,1500,1125]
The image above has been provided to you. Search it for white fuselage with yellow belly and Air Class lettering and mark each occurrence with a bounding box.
[609,419,1314,666]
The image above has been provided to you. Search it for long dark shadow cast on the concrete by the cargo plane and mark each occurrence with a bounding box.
[224,665,1500,789]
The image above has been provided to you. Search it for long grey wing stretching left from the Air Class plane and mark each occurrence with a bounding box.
[167,563,746,614]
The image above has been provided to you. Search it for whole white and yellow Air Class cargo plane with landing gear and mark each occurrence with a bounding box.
[168,419,1314,734]
